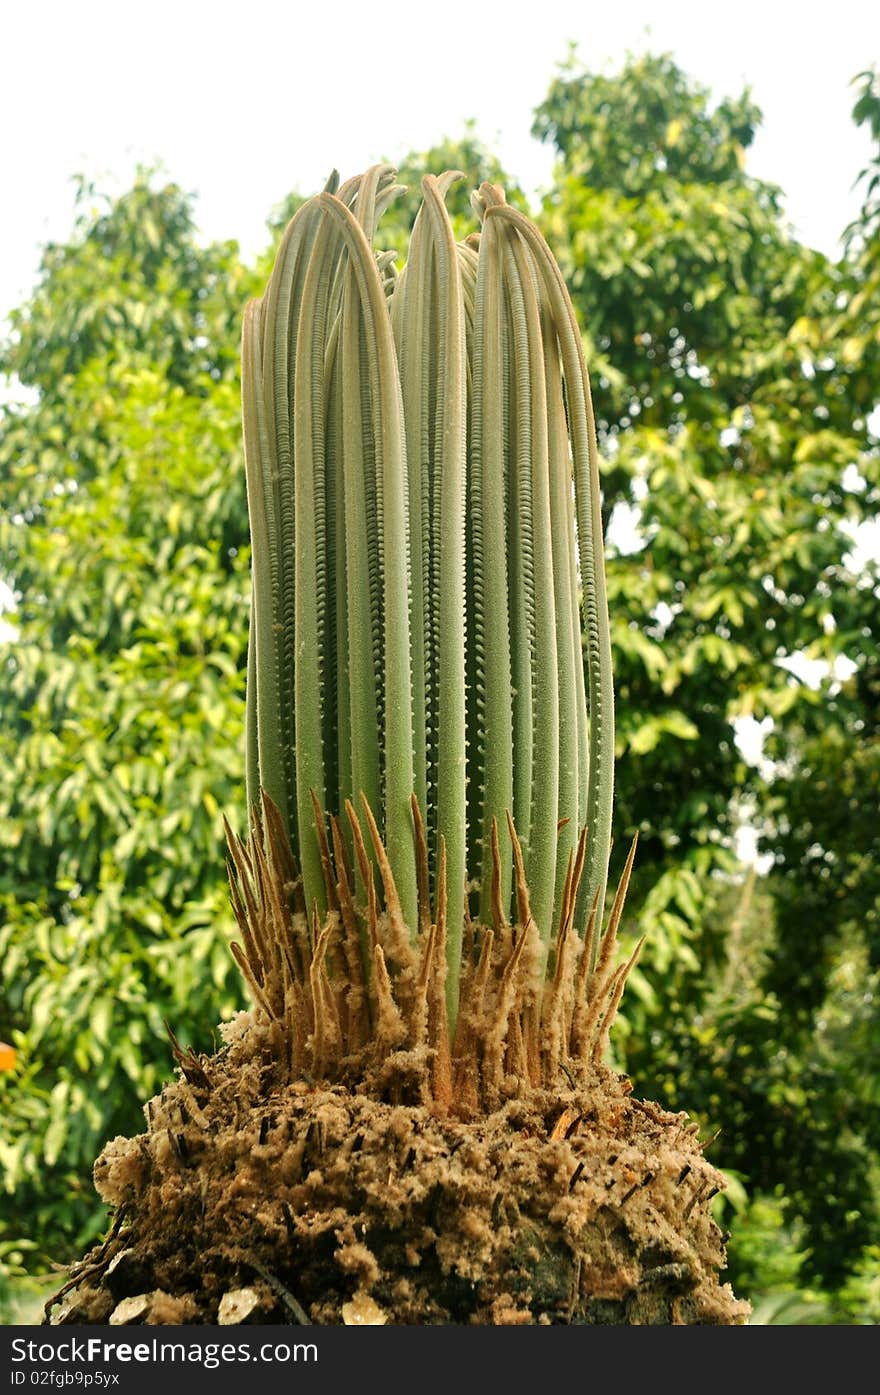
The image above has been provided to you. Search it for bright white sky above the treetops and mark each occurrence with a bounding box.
[0,0,880,319]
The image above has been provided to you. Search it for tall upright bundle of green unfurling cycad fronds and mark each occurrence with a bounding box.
[230,166,623,1089]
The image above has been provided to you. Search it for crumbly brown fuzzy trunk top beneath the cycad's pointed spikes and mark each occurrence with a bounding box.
[47,1014,749,1325]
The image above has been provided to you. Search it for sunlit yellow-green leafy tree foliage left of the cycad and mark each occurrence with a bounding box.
[0,177,259,1257]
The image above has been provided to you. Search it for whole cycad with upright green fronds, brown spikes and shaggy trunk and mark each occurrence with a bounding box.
[47,165,748,1325]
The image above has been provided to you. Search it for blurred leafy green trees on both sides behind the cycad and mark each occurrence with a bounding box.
[0,54,880,1321]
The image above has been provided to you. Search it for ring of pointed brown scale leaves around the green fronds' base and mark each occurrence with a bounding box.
[227,798,642,1115]
